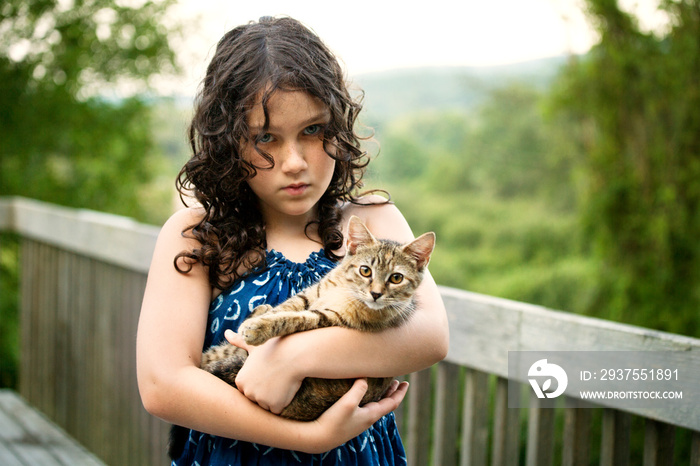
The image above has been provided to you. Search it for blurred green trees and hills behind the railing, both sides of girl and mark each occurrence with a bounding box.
[0,0,700,394]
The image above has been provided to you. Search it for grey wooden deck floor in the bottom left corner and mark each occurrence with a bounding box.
[0,390,104,466]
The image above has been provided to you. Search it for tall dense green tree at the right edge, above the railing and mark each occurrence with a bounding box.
[557,0,700,335]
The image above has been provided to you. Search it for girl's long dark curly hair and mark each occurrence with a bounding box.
[175,17,378,289]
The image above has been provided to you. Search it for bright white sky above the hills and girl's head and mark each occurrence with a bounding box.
[157,0,658,95]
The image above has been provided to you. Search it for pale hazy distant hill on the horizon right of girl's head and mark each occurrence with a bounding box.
[353,56,567,125]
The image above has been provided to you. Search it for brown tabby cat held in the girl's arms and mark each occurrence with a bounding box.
[168,216,435,459]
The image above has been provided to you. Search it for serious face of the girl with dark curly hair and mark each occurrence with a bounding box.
[243,90,335,222]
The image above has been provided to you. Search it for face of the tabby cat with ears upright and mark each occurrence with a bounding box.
[344,217,435,309]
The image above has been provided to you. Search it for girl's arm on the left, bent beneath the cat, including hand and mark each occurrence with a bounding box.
[137,210,406,453]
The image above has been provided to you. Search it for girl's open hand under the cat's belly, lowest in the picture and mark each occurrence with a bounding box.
[309,379,408,453]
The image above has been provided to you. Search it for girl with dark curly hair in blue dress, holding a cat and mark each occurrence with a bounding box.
[137,18,448,466]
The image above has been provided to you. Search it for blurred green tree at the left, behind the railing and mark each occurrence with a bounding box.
[0,0,180,220]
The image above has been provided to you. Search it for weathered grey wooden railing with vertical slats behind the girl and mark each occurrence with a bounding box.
[0,198,700,466]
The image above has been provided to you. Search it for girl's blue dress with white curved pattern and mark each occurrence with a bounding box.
[172,250,406,466]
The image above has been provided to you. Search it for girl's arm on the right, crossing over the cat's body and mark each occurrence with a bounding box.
[227,204,449,413]
